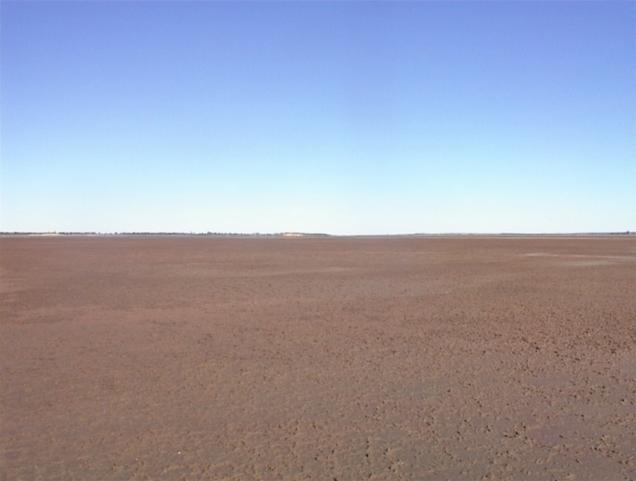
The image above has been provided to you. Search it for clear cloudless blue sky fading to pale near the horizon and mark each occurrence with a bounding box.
[0,1,636,234]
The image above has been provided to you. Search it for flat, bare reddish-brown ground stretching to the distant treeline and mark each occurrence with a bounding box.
[0,237,636,481]
